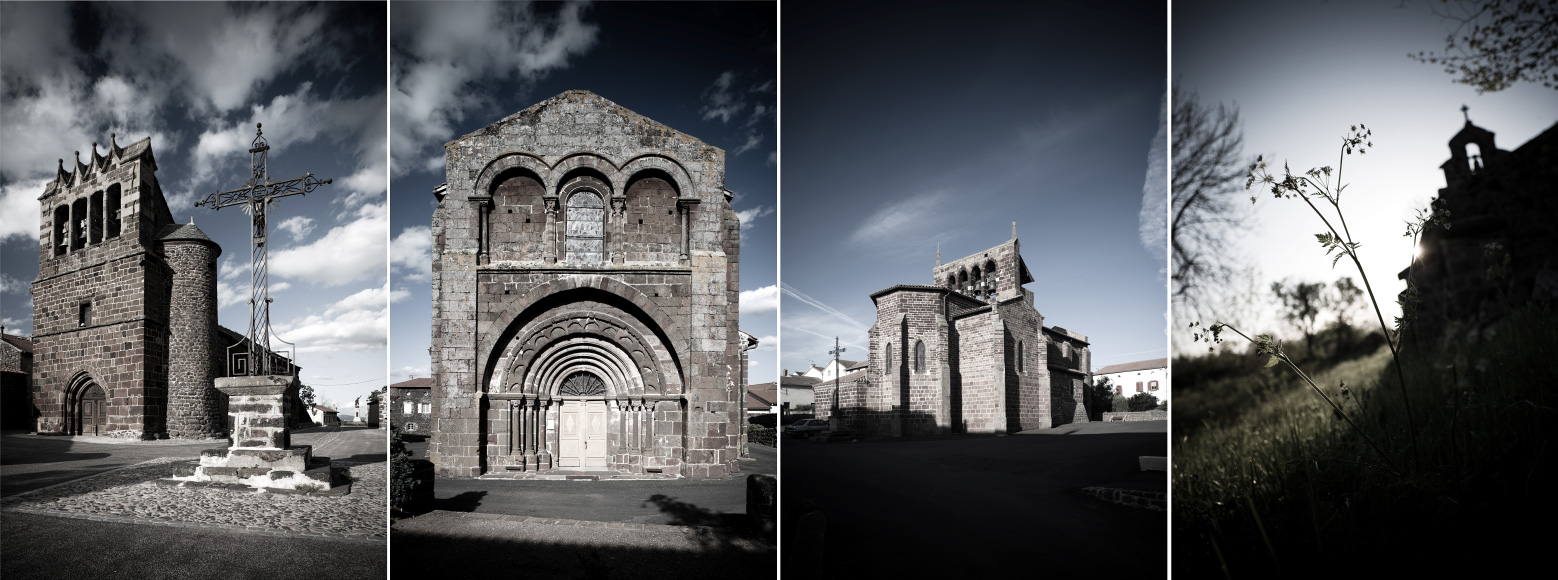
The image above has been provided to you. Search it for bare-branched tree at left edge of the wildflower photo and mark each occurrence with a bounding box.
[1169,87,1250,325]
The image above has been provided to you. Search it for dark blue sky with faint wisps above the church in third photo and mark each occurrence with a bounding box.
[781,2,1167,371]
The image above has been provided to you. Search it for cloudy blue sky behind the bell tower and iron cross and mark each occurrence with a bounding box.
[0,3,391,410]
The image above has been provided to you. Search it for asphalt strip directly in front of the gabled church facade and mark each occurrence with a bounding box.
[420,444,777,525]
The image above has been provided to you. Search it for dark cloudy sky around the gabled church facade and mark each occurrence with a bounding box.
[390,2,779,382]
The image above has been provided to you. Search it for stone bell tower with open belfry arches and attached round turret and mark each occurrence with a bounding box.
[33,137,226,440]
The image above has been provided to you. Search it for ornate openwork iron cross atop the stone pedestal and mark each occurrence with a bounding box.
[195,123,330,376]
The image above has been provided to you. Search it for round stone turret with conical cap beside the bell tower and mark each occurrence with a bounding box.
[159,223,227,438]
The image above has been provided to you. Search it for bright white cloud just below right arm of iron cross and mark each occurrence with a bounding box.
[270,204,390,285]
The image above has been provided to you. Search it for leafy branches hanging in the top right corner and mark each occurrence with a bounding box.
[1407,0,1558,94]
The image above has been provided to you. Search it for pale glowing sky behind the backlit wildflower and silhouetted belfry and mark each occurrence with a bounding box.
[1173,0,1558,345]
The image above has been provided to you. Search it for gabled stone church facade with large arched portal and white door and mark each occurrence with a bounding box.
[428,90,742,477]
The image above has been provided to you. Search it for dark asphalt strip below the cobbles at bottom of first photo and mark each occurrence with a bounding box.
[0,511,388,580]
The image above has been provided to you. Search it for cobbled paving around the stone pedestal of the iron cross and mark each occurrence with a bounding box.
[0,427,386,543]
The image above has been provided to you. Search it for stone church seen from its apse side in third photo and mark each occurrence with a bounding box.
[815,230,1092,437]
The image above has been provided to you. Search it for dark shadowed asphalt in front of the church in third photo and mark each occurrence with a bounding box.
[779,421,1169,578]
